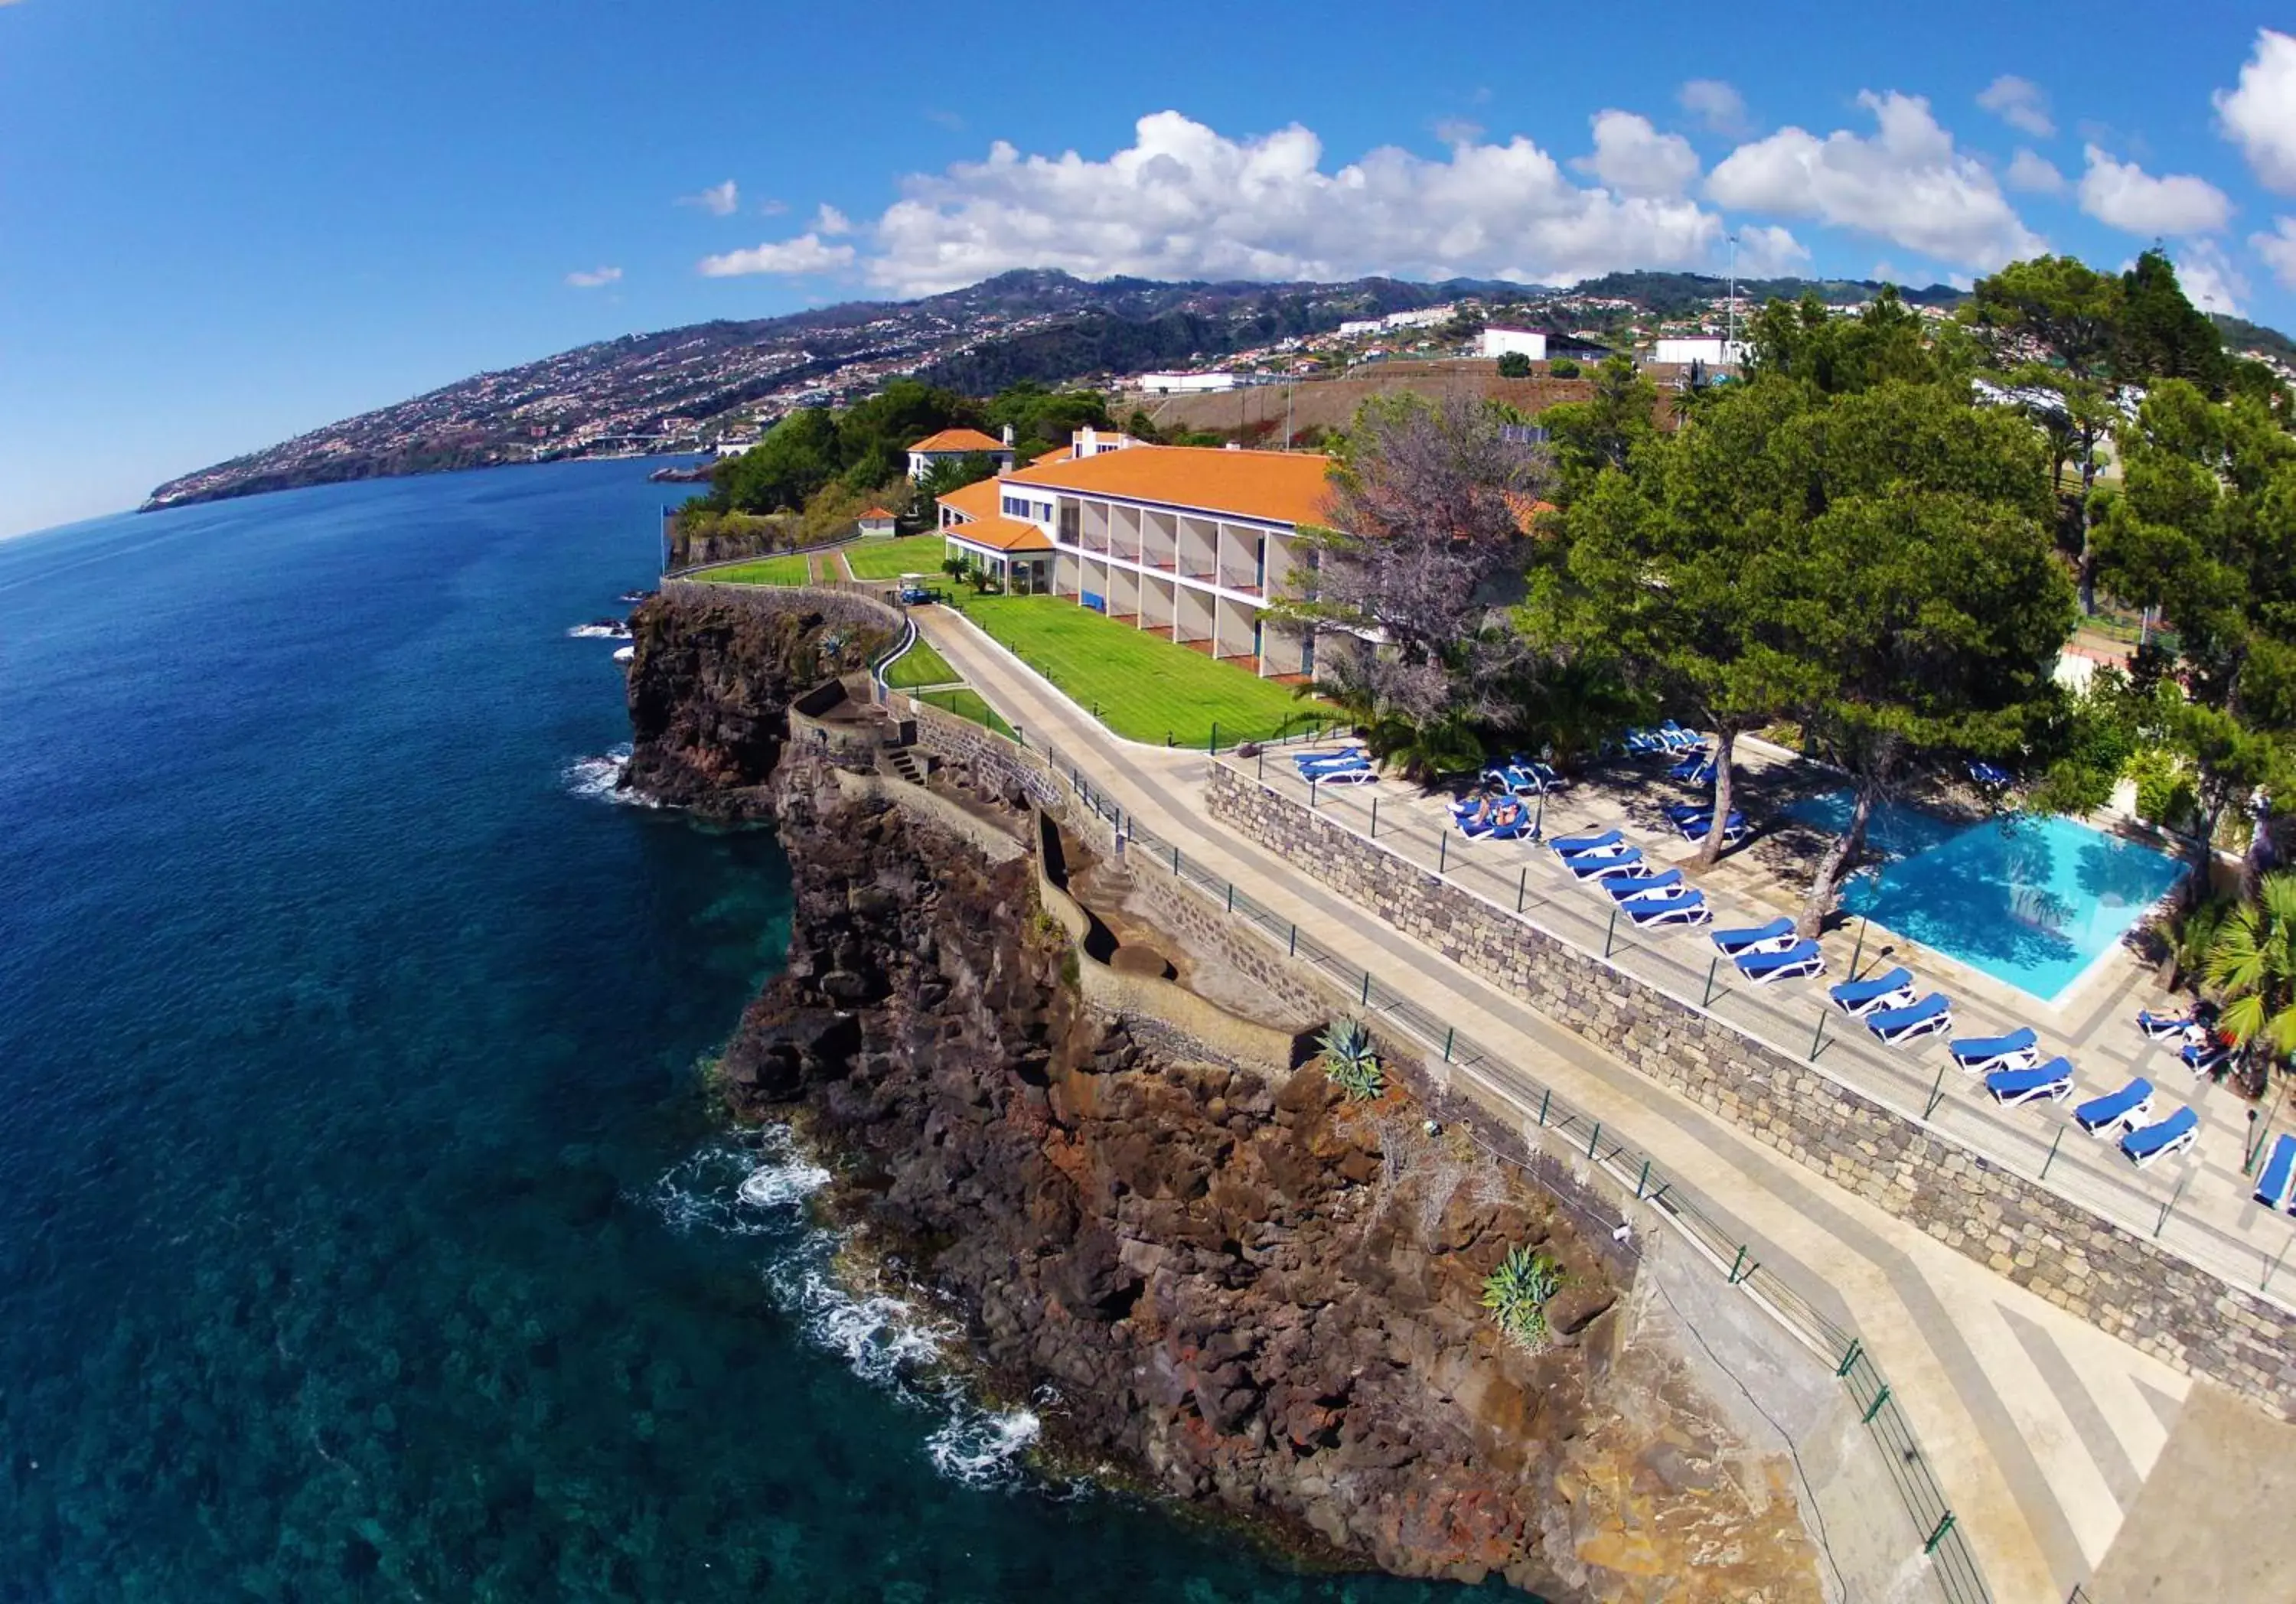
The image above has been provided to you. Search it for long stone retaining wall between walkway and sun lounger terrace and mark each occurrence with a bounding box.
[1182,765,2296,1420]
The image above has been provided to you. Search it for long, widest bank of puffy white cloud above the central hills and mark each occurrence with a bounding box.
[868,112,1722,294]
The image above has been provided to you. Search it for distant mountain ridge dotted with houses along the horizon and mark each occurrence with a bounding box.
[145,269,2103,512]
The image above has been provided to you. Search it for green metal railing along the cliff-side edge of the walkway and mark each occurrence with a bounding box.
[951,730,1993,1604]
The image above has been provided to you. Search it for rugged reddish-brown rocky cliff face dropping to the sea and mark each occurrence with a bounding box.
[625,595,1823,1602]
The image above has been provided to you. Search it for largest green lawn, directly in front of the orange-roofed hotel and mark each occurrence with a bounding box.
[955,595,1320,746]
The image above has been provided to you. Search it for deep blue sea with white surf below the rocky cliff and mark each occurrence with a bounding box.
[0,464,1488,1604]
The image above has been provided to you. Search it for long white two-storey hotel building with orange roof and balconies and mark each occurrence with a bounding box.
[939,429,1329,680]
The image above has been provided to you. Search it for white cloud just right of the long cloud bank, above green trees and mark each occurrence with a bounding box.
[1706,90,2046,269]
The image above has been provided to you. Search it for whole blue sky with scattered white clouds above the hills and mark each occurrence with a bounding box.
[0,0,2296,535]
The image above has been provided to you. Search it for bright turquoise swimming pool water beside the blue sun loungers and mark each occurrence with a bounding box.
[1789,792,2183,1002]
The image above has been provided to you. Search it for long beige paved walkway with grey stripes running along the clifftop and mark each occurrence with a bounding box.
[918,611,2241,1604]
